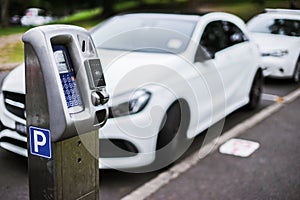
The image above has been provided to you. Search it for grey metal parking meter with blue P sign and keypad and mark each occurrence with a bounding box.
[23,25,109,199]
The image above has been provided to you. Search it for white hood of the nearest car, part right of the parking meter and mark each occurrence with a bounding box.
[98,50,186,96]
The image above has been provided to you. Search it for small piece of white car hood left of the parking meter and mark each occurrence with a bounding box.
[2,64,25,94]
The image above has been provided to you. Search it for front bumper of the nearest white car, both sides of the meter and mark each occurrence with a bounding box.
[0,96,161,169]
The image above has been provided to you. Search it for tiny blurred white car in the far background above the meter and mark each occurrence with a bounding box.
[21,8,53,26]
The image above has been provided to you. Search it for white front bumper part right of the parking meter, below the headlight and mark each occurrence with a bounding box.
[99,109,161,169]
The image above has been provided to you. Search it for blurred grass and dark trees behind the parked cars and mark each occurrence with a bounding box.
[0,0,300,70]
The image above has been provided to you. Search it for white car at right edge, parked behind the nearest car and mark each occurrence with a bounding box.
[247,9,300,82]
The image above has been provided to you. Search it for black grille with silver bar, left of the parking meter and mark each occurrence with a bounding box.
[3,91,26,119]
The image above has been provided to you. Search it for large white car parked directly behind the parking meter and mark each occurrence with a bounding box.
[0,13,263,171]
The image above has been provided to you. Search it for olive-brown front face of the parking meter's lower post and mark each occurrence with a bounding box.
[54,131,99,200]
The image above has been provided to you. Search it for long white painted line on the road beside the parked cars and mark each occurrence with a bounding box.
[122,88,300,200]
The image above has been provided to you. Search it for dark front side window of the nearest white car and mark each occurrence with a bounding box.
[200,21,226,58]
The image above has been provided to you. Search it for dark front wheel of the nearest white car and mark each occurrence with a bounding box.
[154,101,191,169]
